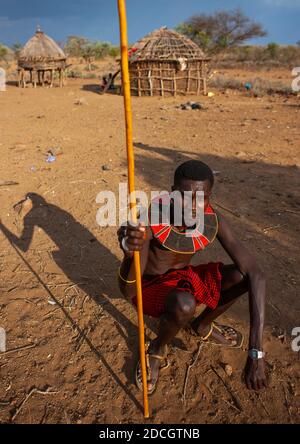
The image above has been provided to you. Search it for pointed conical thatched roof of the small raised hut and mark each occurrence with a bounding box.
[19,28,66,63]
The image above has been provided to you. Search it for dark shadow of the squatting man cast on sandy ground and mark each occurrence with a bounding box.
[0,193,164,392]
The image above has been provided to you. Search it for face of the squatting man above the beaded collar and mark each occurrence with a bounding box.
[172,179,212,225]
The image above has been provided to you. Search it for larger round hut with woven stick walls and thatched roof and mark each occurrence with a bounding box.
[130,28,209,96]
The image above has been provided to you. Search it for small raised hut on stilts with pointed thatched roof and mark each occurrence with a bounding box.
[18,27,67,87]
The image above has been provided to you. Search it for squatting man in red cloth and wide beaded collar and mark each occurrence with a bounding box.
[118,160,267,394]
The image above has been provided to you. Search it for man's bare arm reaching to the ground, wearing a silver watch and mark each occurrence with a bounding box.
[217,213,266,388]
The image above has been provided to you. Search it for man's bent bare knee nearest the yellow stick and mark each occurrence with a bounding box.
[166,290,196,325]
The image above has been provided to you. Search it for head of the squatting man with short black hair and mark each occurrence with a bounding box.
[172,160,214,225]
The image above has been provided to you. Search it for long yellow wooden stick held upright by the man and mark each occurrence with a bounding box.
[118,0,149,418]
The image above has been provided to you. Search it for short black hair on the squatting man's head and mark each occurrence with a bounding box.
[174,160,214,187]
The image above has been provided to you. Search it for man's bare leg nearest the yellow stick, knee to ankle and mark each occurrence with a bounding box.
[139,290,196,391]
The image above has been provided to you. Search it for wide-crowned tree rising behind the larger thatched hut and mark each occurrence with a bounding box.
[177,9,266,55]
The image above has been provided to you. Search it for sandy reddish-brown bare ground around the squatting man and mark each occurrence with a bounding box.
[0,73,300,423]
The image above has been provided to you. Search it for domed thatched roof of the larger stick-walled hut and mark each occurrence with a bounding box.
[132,27,209,61]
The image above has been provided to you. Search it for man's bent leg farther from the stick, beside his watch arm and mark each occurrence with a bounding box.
[192,265,248,344]
